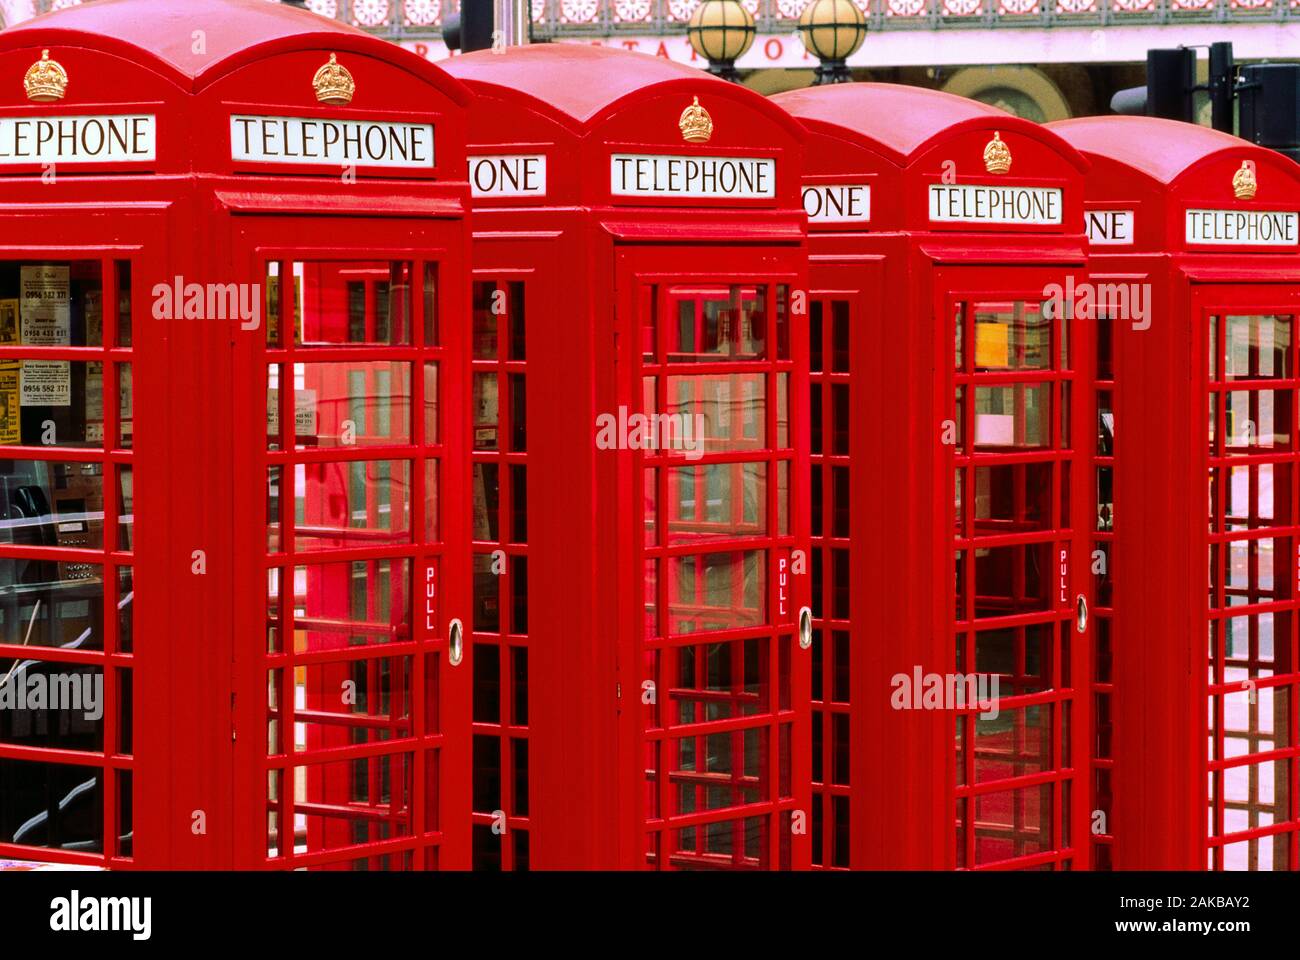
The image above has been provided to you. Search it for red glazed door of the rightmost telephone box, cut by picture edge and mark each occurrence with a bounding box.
[1190,284,1300,870]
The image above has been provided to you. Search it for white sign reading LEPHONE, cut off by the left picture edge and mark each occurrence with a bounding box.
[0,113,157,165]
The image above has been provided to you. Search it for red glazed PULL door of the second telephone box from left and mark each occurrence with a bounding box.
[618,240,811,869]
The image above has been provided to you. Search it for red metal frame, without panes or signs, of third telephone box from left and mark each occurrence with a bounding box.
[774,83,1092,869]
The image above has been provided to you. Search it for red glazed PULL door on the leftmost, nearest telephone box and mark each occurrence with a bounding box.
[235,220,469,870]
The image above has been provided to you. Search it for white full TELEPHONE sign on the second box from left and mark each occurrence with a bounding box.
[610,153,776,200]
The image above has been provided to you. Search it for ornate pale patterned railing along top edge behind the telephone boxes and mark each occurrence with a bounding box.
[30,0,1300,39]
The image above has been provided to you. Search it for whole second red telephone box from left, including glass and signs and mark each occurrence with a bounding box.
[447,44,810,869]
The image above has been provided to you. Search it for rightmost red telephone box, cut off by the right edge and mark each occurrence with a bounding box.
[1050,117,1300,870]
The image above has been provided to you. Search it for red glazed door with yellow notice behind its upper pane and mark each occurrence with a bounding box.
[939,261,1095,869]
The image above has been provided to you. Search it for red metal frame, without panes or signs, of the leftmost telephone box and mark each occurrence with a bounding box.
[0,0,469,869]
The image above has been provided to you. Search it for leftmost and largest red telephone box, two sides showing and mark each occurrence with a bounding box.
[0,0,469,869]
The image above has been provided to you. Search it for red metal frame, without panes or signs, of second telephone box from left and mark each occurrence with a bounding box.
[447,44,810,869]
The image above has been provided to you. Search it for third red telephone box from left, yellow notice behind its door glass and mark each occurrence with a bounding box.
[774,83,1092,869]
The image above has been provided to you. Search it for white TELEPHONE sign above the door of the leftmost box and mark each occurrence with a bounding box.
[230,114,433,170]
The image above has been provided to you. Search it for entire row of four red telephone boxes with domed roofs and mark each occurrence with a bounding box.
[0,0,1300,869]
